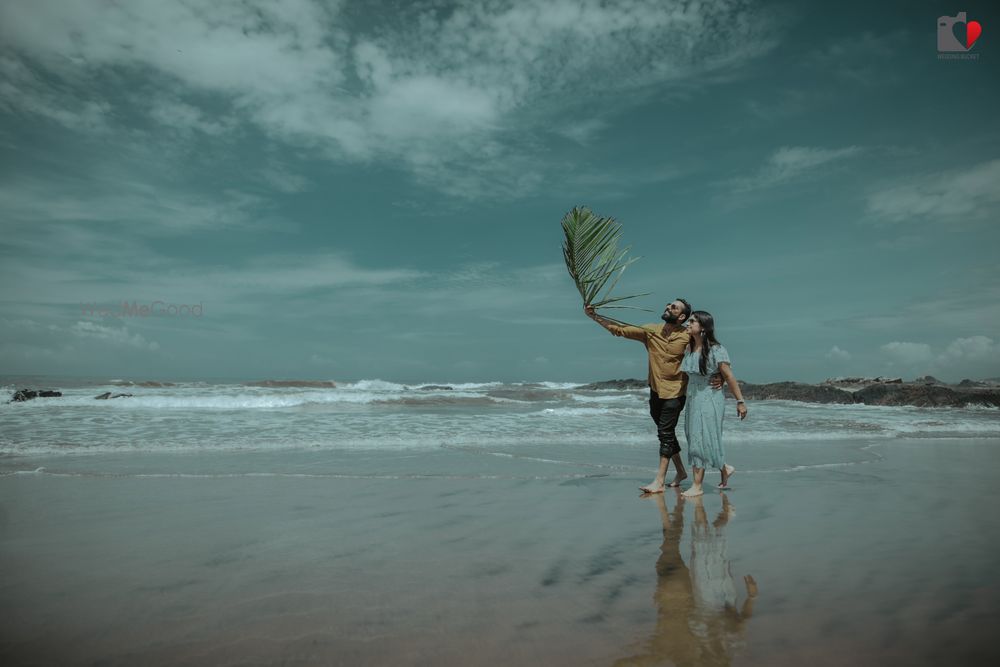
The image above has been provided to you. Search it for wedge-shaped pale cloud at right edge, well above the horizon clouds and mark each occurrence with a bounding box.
[868,159,1000,222]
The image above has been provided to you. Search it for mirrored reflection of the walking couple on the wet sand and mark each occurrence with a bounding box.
[615,493,757,666]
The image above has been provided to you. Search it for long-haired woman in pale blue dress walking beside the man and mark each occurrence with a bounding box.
[681,310,747,498]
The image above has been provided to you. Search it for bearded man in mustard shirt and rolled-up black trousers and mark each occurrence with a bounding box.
[583,299,722,493]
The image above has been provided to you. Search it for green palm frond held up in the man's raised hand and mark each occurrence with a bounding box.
[562,206,652,322]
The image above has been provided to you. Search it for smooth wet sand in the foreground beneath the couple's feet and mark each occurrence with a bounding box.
[0,439,1000,665]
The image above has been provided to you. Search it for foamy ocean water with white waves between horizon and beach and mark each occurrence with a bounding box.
[0,378,1000,464]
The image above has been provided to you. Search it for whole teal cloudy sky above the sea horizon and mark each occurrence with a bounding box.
[0,0,1000,383]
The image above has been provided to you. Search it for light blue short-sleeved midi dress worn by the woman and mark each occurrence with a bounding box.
[681,345,730,470]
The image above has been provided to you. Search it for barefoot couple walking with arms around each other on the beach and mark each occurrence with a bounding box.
[584,299,747,497]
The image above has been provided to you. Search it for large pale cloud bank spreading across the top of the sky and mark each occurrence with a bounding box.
[0,0,775,197]
